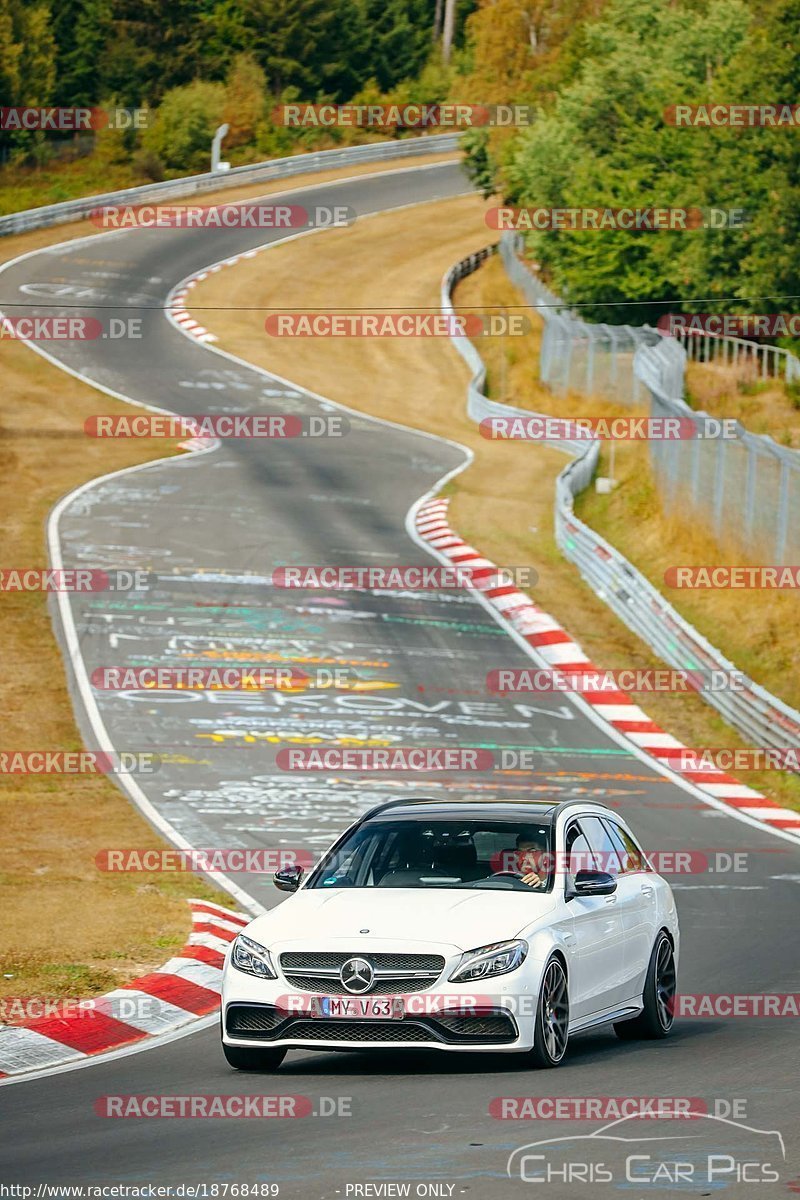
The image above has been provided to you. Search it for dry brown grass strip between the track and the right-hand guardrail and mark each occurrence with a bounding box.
[192,206,800,808]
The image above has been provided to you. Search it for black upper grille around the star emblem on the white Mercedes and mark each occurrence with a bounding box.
[281,950,445,996]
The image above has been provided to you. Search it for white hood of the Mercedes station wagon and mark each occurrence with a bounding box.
[247,888,554,950]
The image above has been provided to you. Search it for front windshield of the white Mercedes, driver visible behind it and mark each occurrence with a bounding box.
[307,816,553,892]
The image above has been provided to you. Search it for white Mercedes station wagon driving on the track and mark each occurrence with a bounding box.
[222,799,679,1070]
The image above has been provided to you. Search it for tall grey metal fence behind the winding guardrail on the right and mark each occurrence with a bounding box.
[500,234,800,563]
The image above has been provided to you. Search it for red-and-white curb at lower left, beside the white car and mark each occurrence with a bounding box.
[0,900,251,1078]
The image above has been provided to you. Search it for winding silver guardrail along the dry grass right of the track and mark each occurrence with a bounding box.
[441,247,800,750]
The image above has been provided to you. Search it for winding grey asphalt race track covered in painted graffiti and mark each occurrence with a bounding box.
[0,163,800,1200]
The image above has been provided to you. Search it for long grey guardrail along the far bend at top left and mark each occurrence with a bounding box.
[0,133,459,238]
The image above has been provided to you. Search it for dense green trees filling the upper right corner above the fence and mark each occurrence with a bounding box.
[467,0,800,323]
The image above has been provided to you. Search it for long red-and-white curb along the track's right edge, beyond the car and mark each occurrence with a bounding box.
[416,499,800,833]
